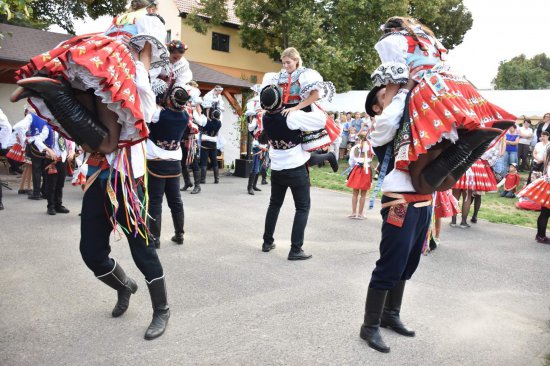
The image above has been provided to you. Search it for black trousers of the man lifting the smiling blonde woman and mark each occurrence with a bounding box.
[263,165,311,252]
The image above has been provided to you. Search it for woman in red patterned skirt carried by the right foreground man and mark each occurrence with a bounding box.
[372,17,516,193]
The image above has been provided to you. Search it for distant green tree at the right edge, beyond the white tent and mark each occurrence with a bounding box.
[493,53,550,90]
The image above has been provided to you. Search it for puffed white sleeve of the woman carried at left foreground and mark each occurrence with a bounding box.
[130,15,169,72]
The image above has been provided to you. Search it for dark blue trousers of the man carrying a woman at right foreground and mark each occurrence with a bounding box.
[369,196,431,290]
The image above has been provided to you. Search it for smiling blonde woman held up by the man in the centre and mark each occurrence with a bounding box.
[262,47,340,172]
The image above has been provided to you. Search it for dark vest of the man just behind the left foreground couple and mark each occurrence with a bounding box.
[149,109,189,150]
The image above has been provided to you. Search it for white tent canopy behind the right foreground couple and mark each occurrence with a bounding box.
[322,89,550,118]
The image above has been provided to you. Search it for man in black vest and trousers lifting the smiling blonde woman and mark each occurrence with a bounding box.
[260,85,325,260]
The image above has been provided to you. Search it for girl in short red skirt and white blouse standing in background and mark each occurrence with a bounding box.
[346,133,374,220]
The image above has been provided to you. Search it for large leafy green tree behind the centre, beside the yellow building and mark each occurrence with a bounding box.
[188,0,472,91]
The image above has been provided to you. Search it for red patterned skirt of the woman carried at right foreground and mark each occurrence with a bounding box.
[396,74,516,169]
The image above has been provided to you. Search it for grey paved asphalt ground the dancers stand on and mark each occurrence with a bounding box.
[0,172,550,366]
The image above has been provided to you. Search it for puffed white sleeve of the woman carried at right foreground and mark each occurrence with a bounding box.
[371,33,409,86]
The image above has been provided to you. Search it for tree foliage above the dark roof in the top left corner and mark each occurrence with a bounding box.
[0,0,127,34]
